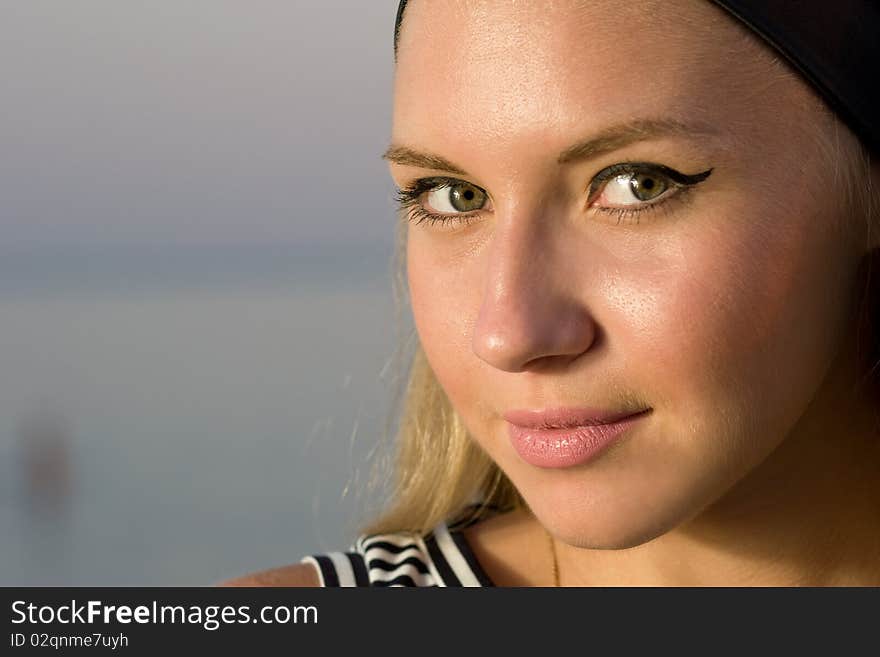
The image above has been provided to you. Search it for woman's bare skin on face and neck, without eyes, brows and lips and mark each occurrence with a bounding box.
[388,0,880,586]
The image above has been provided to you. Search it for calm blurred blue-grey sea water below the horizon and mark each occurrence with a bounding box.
[0,245,405,586]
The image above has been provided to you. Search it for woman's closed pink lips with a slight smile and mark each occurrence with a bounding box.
[504,408,651,468]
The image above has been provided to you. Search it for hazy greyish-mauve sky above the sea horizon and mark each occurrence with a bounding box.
[0,0,397,252]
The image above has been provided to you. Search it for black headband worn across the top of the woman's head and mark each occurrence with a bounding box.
[394,0,880,153]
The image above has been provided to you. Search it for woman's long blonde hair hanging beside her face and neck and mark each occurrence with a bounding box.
[362,111,880,534]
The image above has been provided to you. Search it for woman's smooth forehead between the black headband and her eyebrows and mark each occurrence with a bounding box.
[393,0,796,152]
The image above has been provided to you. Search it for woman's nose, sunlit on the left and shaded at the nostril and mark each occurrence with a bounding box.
[473,214,597,372]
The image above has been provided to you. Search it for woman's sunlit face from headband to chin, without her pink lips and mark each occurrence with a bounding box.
[387,0,864,547]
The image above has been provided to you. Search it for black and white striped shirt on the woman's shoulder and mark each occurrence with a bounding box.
[302,523,494,586]
